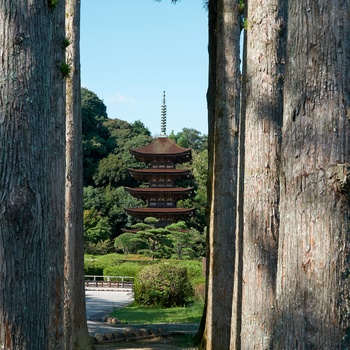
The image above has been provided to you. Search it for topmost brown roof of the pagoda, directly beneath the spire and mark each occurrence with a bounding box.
[130,137,191,157]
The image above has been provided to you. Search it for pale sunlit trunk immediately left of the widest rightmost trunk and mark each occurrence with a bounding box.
[241,0,286,350]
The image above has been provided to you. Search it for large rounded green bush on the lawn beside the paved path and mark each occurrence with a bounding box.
[134,263,194,307]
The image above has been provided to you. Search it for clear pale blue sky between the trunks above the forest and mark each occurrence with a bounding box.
[80,0,208,135]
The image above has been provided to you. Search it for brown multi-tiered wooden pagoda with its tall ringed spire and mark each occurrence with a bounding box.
[125,92,194,227]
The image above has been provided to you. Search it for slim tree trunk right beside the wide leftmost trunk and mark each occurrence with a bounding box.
[64,0,92,350]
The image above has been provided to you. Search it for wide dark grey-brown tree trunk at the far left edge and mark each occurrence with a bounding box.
[0,0,65,350]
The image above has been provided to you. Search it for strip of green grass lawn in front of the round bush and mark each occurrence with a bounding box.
[110,302,203,324]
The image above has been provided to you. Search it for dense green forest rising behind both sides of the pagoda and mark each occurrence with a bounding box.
[81,88,208,257]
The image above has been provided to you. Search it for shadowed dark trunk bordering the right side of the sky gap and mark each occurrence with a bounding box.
[201,0,240,350]
